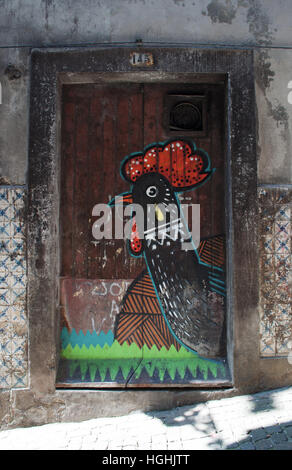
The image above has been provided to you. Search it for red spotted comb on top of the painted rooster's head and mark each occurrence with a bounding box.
[121,139,212,191]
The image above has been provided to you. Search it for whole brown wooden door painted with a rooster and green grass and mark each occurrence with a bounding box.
[57,83,228,387]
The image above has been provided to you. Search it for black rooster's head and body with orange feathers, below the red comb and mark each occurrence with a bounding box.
[109,141,225,357]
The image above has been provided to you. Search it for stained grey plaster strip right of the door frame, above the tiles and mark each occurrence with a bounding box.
[255,48,292,184]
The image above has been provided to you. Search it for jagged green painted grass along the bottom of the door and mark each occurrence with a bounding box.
[61,341,225,382]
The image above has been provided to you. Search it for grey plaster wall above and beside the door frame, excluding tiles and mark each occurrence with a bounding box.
[0,0,292,184]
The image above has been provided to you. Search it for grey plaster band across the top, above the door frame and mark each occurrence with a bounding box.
[0,0,291,46]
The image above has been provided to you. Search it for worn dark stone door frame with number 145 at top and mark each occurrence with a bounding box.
[28,47,259,414]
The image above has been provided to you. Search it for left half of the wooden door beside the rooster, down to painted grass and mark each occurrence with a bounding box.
[58,85,144,386]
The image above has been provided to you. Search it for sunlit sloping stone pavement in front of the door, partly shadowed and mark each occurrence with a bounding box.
[0,387,292,451]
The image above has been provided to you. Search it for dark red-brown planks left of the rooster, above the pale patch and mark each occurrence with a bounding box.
[61,85,143,279]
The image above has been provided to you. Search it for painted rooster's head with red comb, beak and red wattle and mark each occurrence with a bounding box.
[110,139,213,256]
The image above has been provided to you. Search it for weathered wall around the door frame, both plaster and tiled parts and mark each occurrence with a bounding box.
[0,0,292,425]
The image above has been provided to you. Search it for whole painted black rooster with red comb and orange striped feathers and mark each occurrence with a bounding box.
[110,139,225,357]
